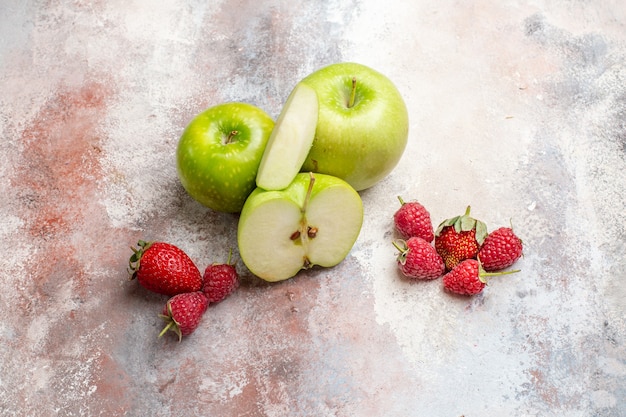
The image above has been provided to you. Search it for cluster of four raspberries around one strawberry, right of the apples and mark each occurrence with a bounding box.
[393,197,523,295]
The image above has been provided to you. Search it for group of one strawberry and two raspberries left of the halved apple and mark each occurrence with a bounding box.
[129,240,239,341]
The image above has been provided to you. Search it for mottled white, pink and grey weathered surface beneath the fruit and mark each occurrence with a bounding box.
[0,0,626,417]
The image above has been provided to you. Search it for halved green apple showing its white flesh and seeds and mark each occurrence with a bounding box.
[237,173,363,282]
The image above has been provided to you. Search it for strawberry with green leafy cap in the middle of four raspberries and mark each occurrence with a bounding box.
[435,206,487,271]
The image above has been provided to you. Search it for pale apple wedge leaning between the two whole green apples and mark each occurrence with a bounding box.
[256,83,319,190]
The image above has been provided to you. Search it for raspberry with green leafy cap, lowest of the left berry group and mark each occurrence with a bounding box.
[159,291,209,341]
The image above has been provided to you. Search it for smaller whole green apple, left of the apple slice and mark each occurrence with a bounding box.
[176,102,274,213]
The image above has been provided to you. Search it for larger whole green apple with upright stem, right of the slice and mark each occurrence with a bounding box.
[301,62,409,191]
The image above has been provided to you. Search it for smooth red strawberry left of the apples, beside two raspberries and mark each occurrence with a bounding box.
[129,240,202,296]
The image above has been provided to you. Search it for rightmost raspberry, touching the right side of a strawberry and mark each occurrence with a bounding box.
[478,227,523,271]
